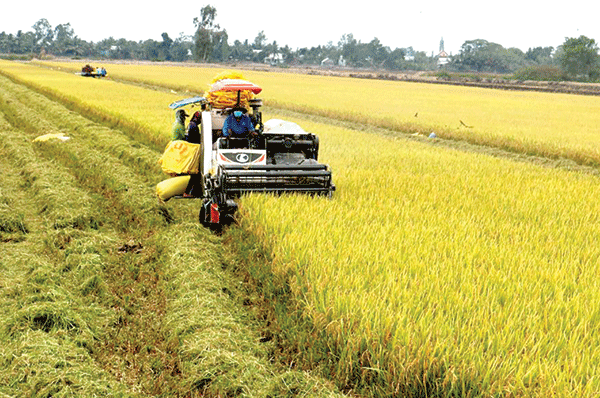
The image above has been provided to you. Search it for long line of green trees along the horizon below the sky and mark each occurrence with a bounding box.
[0,5,600,81]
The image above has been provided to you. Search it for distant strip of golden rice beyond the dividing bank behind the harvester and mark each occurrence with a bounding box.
[36,59,600,164]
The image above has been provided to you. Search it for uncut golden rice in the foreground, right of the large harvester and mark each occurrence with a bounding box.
[236,113,600,397]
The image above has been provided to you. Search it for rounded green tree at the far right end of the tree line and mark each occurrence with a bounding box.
[558,36,600,80]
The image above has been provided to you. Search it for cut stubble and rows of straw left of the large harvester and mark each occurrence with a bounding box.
[0,63,350,397]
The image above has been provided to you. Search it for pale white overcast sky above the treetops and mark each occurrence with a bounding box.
[0,0,600,54]
